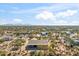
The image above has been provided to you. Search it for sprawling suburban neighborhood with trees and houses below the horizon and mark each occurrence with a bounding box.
[0,26,79,56]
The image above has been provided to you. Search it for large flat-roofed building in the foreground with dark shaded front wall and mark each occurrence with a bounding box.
[25,40,50,50]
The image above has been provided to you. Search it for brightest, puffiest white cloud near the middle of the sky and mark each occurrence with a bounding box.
[35,11,55,20]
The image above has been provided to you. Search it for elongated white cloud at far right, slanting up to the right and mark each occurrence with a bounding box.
[56,10,78,17]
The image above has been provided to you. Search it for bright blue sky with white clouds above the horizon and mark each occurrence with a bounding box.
[0,3,79,25]
